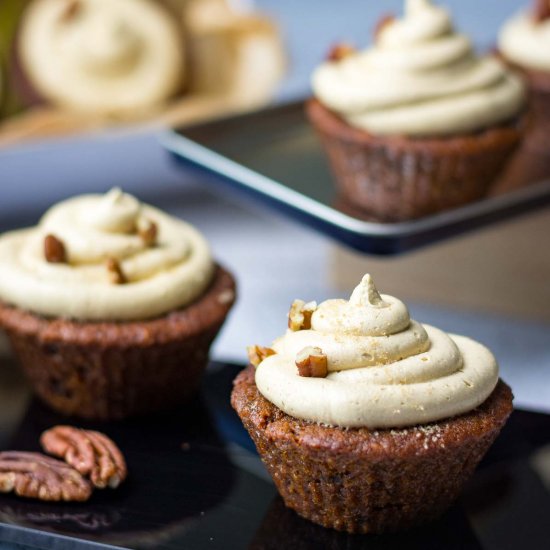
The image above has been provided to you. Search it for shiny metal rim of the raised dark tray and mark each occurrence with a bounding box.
[157,101,550,254]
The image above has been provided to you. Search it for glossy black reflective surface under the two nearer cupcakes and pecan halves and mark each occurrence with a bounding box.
[0,362,550,550]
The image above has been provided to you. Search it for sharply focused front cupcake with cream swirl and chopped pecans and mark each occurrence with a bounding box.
[231,275,512,533]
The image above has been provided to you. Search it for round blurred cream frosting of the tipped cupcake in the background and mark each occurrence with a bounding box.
[20,0,185,114]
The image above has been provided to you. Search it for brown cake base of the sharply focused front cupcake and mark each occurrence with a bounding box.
[231,367,512,533]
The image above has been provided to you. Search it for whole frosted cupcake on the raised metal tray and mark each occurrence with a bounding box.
[307,0,525,221]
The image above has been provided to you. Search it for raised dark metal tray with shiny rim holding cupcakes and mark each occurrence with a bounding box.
[160,102,550,254]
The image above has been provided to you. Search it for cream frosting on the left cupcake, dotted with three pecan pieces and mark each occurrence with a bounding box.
[0,189,214,321]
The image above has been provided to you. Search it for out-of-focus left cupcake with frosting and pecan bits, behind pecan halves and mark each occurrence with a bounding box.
[0,189,235,419]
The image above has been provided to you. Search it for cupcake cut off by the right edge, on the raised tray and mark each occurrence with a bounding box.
[498,0,550,190]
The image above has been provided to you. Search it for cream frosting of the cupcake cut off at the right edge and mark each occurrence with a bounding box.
[498,13,550,71]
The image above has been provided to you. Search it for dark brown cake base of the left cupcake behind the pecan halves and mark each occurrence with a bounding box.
[0,267,235,420]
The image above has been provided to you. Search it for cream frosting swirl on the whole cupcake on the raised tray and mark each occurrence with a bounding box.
[312,0,525,136]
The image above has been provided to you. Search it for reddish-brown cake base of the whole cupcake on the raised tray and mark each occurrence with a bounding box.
[306,99,523,222]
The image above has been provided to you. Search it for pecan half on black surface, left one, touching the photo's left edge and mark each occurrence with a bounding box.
[0,451,92,502]
